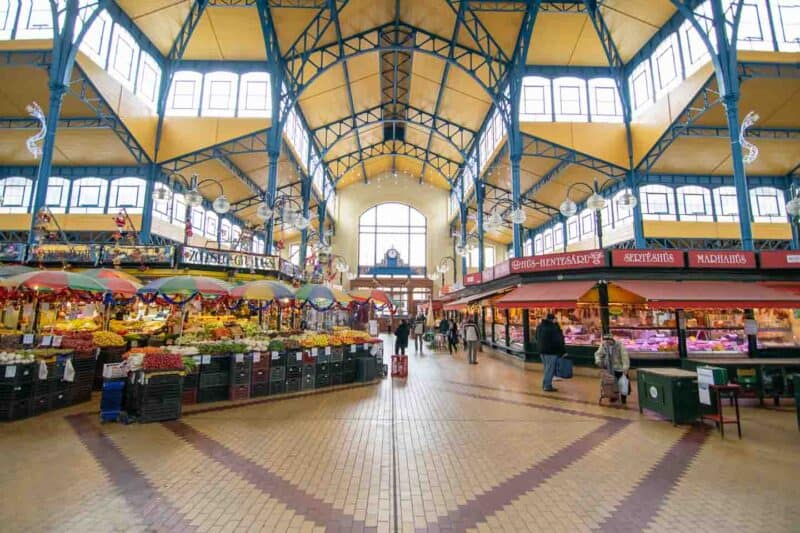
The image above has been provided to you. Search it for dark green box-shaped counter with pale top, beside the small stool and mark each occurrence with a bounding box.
[636,368,700,425]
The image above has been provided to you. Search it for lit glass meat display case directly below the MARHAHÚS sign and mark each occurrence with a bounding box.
[686,309,747,357]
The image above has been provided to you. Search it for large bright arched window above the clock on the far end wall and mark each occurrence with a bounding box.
[358,202,427,267]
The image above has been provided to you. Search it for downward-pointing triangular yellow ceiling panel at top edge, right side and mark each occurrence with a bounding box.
[600,0,675,62]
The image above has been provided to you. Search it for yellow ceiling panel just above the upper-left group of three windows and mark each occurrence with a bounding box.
[205,8,267,61]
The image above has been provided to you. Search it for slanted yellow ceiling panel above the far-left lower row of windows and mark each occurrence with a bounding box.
[56,128,136,165]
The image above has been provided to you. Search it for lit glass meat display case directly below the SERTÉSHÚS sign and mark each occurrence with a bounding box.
[609,306,679,359]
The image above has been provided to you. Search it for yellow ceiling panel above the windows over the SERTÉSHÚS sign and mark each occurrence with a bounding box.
[653,137,730,174]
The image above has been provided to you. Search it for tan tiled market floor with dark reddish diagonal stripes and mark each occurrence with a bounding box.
[0,338,800,533]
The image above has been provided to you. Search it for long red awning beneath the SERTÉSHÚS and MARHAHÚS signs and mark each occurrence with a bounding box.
[613,280,800,309]
